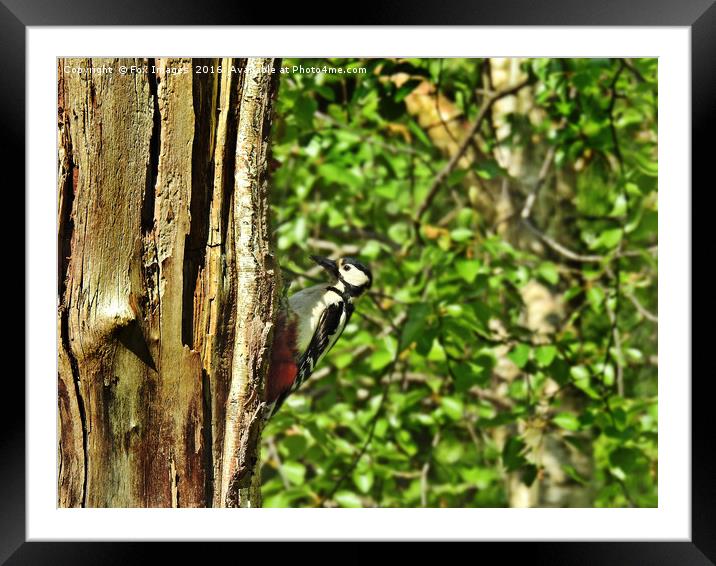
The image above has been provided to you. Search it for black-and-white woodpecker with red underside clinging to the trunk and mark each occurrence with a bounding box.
[265,256,373,419]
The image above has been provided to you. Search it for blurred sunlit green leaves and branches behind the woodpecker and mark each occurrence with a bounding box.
[263,59,658,507]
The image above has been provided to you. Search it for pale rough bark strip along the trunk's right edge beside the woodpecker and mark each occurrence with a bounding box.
[221,59,280,507]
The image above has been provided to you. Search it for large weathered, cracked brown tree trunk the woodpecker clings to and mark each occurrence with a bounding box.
[58,59,280,507]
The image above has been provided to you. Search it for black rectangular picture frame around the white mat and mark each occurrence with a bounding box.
[7,0,716,566]
